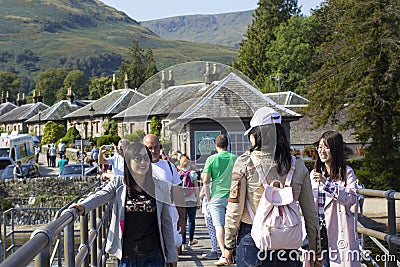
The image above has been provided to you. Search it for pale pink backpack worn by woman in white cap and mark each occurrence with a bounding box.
[246,153,303,251]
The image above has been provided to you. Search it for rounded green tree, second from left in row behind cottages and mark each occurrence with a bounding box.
[35,69,67,106]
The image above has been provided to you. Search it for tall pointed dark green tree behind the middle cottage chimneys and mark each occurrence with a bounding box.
[118,41,157,88]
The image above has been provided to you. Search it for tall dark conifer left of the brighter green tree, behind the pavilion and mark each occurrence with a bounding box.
[233,0,300,92]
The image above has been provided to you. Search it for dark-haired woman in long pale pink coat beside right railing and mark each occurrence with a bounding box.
[310,131,361,267]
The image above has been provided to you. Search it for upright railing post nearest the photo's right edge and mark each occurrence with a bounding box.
[385,190,397,267]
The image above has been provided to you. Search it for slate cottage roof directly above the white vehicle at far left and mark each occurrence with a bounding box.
[0,102,49,123]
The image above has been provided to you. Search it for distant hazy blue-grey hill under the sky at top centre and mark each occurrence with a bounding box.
[140,10,253,48]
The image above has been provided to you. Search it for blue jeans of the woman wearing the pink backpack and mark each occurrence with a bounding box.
[236,223,302,267]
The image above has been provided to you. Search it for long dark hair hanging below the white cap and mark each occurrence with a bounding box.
[249,124,292,175]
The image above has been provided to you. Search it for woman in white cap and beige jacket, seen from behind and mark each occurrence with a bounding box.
[225,107,320,267]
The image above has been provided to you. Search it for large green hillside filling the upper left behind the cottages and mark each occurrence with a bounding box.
[0,0,237,92]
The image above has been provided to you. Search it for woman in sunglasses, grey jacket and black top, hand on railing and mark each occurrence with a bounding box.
[70,143,177,267]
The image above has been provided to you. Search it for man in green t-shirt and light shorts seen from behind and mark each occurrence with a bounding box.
[202,135,237,266]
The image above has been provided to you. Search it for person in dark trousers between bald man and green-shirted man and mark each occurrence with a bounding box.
[178,155,200,252]
